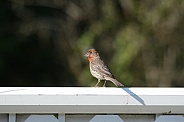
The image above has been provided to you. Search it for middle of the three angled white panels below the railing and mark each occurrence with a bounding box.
[89,115,124,122]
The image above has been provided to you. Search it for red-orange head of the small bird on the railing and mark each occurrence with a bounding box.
[85,49,99,62]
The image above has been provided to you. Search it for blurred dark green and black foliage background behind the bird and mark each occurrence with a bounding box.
[0,0,184,87]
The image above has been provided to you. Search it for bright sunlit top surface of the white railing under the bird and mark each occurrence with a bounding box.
[0,87,184,95]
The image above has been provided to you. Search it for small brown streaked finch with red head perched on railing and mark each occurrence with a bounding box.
[85,49,124,87]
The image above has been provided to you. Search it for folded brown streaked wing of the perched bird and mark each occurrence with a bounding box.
[91,59,114,77]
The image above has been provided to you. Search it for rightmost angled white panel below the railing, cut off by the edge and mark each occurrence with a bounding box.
[155,115,184,122]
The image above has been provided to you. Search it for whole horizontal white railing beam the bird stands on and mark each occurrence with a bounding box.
[0,87,184,114]
